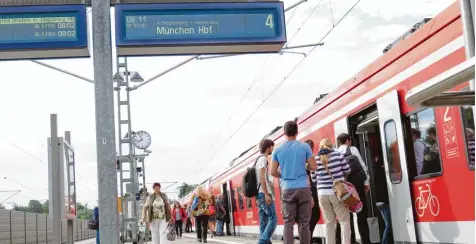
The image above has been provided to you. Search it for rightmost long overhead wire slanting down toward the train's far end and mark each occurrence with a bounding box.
[197,0,361,173]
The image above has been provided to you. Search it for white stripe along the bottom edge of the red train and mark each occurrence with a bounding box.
[235,221,475,243]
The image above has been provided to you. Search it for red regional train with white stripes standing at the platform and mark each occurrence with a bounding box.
[181,2,475,243]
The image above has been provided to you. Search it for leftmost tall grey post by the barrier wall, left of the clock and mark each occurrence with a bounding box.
[49,114,61,244]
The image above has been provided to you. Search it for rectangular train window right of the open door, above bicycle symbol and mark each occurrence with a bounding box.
[409,108,441,179]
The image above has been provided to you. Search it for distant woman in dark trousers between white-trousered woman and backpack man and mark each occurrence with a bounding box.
[192,186,210,243]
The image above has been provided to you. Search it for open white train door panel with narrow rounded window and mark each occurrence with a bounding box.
[377,90,417,243]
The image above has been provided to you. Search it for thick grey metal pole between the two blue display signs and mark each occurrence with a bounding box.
[91,0,119,244]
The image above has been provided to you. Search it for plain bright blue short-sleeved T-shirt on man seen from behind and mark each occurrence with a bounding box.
[272,140,313,190]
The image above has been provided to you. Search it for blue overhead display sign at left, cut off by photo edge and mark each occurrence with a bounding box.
[0,5,89,60]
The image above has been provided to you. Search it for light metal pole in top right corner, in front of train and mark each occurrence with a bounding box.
[460,0,475,114]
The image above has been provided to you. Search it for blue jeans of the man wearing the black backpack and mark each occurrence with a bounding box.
[256,192,277,244]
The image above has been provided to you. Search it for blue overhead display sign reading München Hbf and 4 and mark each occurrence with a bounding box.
[115,2,286,56]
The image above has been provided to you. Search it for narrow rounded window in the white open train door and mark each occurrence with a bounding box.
[384,120,402,184]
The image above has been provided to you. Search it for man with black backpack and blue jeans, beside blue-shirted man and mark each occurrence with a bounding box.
[244,139,278,244]
